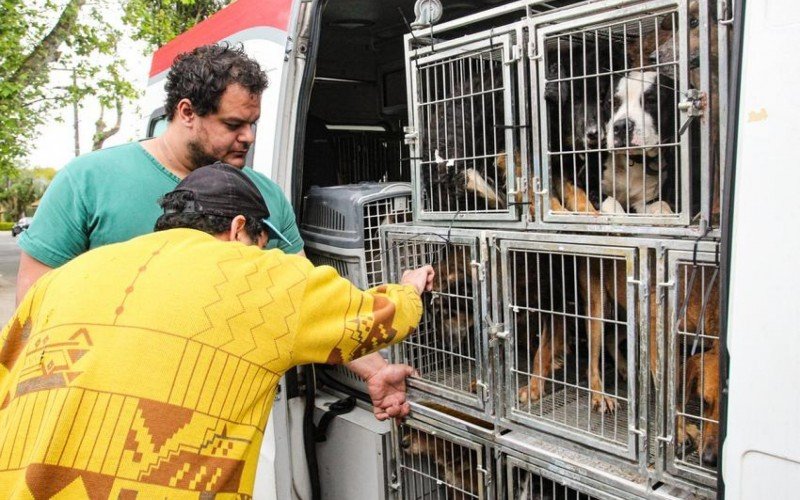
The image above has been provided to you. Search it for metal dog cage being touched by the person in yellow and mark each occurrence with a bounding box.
[385,227,491,416]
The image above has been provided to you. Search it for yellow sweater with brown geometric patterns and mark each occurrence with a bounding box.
[0,229,422,499]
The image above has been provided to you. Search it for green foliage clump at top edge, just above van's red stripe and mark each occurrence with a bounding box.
[123,0,231,49]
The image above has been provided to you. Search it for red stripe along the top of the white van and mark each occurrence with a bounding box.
[150,0,293,78]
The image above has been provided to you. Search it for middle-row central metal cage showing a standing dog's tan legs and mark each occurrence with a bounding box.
[497,235,647,460]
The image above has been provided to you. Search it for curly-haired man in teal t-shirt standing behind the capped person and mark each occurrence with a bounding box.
[17,44,412,419]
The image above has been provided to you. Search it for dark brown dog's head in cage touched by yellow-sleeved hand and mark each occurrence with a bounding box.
[428,245,474,352]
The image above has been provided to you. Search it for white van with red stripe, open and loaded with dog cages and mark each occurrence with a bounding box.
[143,0,800,499]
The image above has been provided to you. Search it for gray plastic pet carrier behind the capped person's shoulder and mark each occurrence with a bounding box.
[300,182,411,289]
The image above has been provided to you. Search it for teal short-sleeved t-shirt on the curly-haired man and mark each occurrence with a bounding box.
[19,142,303,267]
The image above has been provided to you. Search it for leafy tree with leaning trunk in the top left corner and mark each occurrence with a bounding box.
[0,0,136,175]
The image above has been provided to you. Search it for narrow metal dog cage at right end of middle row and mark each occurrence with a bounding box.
[662,251,722,486]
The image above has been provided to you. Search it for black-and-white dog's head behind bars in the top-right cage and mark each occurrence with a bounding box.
[605,71,677,154]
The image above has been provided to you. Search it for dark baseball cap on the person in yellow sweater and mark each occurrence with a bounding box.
[164,162,291,244]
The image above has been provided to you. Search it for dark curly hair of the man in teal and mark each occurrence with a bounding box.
[164,42,269,120]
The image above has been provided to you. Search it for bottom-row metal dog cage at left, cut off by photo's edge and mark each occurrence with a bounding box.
[394,420,493,500]
